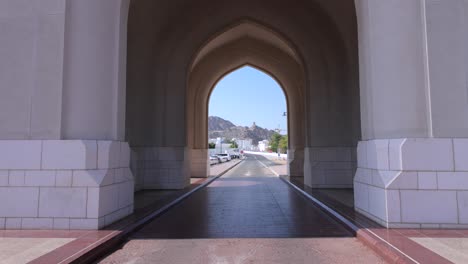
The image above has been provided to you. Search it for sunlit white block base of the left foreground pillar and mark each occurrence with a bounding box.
[0,140,134,230]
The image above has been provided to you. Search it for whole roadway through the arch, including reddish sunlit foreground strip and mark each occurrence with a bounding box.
[98,156,383,263]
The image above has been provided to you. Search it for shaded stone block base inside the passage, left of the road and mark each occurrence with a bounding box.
[132,147,190,190]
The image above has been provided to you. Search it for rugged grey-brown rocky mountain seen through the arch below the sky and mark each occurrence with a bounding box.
[208,116,275,145]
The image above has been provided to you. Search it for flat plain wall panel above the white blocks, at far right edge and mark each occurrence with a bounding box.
[423,0,468,138]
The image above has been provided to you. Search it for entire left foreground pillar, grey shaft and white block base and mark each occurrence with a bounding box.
[0,0,134,229]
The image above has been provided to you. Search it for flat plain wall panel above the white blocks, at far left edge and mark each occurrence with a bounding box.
[0,0,65,139]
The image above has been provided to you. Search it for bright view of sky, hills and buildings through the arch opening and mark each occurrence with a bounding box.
[207,64,289,165]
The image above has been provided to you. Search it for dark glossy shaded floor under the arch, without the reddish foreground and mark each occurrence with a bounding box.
[130,159,353,238]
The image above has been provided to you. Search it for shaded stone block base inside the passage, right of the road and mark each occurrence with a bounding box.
[304,147,356,188]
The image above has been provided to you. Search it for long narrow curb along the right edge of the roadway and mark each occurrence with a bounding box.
[280,177,419,264]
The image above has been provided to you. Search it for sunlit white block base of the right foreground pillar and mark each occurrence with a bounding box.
[354,138,468,228]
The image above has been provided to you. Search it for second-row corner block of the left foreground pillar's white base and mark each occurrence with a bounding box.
[73,169,114,187]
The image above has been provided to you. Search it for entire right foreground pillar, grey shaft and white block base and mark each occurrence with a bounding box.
[354,0,468,228]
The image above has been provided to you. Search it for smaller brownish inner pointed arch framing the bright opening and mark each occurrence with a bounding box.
[186,21,305,177]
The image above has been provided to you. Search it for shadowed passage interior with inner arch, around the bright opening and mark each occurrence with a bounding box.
[126,0,361,189]
